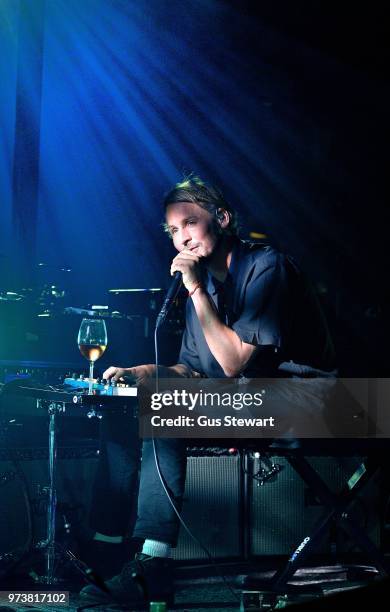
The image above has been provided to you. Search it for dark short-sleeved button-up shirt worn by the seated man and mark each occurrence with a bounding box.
[179,240,334,378]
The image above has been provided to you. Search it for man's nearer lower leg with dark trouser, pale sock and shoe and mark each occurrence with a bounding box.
[81,439,186,605]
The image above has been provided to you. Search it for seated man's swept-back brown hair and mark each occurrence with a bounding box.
[163,174,238,236]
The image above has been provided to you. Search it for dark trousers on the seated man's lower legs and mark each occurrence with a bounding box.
[90,415,186,546]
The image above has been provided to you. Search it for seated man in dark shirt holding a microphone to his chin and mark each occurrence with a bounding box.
[82,177,333,605]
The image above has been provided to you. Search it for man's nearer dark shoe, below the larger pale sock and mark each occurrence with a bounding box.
[80,553,173,608]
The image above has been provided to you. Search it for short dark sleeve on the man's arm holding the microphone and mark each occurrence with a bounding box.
[232,252,290,348]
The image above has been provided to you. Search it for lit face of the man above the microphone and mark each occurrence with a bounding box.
[166,202,219,257]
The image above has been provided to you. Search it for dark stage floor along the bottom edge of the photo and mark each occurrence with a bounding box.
[0,560,390,612]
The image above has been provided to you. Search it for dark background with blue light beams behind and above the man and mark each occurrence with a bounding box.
[0,0,390,376]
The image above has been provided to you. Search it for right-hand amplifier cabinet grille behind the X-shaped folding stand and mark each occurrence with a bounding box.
[250,456,380,556]
